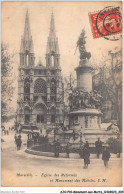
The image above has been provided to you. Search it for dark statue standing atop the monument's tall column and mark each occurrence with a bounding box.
[76,29,91,60]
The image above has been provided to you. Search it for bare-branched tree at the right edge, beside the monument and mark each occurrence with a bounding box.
[94,48,122,131]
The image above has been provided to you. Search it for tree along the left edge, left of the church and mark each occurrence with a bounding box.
[1,43,14,122]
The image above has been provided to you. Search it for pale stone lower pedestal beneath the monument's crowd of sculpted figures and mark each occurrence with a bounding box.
[69,108,104,143]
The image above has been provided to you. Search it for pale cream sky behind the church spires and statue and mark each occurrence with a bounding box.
[1,1,122,110]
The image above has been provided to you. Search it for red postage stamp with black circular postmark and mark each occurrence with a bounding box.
[89,6,122,39]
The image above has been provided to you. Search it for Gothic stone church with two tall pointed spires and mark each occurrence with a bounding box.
[17,11,64,129]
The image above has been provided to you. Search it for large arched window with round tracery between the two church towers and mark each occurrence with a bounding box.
[34,78,47,94]
